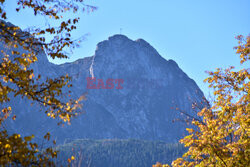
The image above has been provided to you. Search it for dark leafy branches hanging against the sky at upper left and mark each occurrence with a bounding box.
[0,0,97,58]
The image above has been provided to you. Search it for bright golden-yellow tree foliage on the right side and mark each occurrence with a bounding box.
[154,36,250,167]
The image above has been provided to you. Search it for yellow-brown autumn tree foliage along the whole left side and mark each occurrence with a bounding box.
[0,0,96,166]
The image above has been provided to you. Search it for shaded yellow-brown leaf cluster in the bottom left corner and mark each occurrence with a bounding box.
[0,131,57,166]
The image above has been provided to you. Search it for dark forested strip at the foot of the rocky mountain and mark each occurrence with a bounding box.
[57,139,186,167]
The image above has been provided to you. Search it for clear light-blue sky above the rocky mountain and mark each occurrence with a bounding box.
[3,0,250,95]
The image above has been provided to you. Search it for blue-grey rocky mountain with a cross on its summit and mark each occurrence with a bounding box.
[0,23,203,143]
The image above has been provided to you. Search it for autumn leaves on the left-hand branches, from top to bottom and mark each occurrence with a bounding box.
[0,1,93,166]
